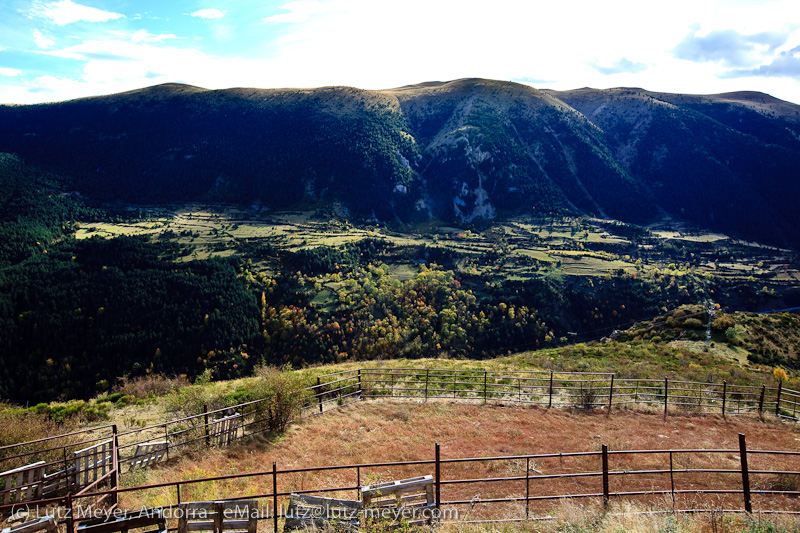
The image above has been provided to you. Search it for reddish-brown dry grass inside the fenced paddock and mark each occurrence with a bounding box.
[117,401,800,520]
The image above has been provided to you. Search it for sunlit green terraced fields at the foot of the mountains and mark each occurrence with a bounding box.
[76,205,800,285]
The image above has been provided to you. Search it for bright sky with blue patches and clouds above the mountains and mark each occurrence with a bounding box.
[0,0,800,104]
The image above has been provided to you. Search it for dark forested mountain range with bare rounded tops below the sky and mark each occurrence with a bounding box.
[0,79,800,247]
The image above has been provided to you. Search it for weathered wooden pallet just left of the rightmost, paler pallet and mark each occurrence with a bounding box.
[283,494,363,531]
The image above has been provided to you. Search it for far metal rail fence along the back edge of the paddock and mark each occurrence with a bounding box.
[361,368,800,421]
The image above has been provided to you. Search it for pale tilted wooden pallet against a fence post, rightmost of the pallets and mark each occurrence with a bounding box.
[361,476,436,526]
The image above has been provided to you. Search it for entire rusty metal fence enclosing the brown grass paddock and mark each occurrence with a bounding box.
[0,368,800,531]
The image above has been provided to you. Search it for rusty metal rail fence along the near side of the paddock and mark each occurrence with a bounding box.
[0,435,800,533]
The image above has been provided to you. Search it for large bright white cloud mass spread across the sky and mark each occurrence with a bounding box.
[0,0,800,106]
